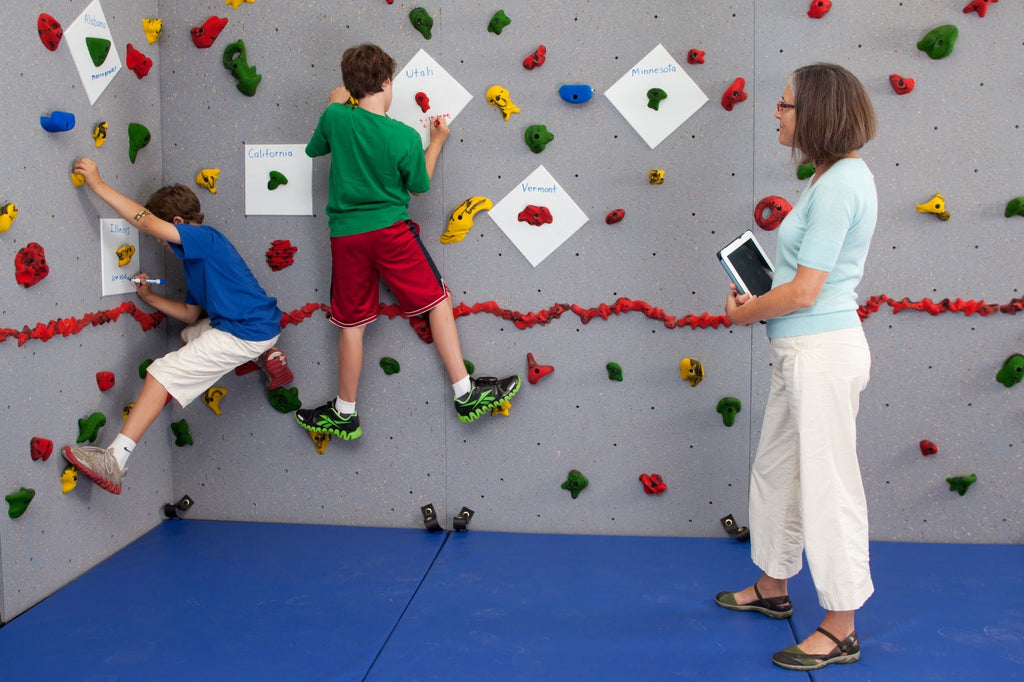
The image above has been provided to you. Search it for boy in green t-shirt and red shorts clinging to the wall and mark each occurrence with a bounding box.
[296,44,520,440]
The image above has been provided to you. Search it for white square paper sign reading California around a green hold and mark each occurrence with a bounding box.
[245,144,313,215]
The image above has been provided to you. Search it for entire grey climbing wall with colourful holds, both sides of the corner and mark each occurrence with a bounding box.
[0,0,1024,620]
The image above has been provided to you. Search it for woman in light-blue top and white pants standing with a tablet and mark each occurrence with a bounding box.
[715,63,878,671]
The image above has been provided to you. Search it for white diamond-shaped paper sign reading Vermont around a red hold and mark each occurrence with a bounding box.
[487,166,588,267]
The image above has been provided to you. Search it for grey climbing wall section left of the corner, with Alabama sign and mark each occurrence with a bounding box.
[0,0,172,621]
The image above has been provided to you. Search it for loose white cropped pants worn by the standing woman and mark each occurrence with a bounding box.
[750,327,874,611]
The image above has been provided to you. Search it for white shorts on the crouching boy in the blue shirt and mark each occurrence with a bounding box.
[146,317,278,408]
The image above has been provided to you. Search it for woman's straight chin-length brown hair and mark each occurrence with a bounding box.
[790,63,878,164]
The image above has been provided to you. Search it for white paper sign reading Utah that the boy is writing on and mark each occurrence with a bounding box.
[388,49,473,150]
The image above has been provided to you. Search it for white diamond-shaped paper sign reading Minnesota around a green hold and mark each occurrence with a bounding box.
[604,45,708,150]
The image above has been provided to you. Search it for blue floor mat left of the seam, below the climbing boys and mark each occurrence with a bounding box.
[0,521,443,682]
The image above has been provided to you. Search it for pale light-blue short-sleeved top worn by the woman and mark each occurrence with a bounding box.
[768,153,879,338]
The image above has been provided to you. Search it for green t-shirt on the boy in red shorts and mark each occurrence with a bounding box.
[306,103,430,237]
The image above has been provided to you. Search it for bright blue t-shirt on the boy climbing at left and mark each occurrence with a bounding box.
[168,224,282,341]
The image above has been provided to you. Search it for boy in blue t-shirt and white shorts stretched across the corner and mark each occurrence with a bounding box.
[63,159,292,495]
